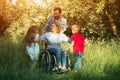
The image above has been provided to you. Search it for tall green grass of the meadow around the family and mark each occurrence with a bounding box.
[0,38,120,80]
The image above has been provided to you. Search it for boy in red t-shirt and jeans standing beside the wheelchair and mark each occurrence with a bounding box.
[64,25,88,72]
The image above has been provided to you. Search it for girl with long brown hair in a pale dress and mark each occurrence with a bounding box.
[23,26,40,70]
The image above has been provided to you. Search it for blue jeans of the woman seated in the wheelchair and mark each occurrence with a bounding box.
[48,48,66,66]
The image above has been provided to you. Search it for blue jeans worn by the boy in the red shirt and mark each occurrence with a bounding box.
[74,53,82,71]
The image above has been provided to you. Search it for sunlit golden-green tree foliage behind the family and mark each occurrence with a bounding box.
[0,0,120,39]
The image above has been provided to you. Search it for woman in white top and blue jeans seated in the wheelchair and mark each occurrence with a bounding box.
[41,22,69,72]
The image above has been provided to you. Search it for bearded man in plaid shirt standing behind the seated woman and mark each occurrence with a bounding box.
[42,7,67,33]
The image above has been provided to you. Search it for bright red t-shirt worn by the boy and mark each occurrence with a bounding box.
[71,33,85,54]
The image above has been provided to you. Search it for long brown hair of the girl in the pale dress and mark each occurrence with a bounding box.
[23,26,38,46]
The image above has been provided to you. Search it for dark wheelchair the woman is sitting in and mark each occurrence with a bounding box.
[38,42,70,73]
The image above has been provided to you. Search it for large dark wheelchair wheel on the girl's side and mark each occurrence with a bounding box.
[39,50,51,73]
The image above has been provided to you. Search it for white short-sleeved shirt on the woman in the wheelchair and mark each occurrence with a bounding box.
[41,32,69,49]
